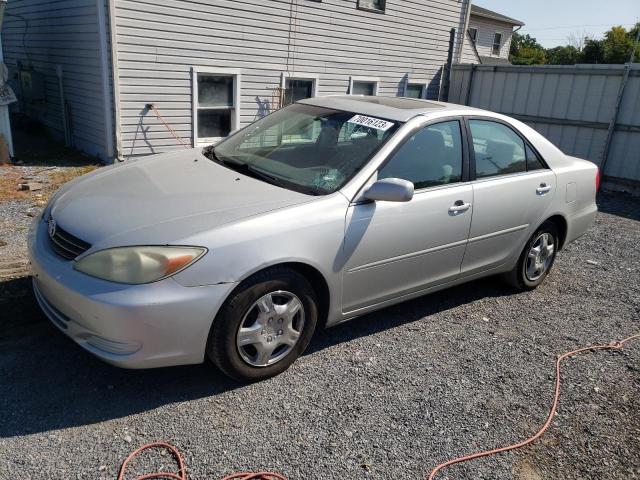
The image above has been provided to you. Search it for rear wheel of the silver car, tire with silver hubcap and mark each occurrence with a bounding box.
[504,221,559,291]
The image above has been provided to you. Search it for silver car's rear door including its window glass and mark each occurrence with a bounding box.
[462,117,556,274]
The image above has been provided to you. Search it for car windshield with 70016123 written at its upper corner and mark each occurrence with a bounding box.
[203,104,398,195]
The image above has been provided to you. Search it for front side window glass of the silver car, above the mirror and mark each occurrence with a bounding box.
[378,120,462,190]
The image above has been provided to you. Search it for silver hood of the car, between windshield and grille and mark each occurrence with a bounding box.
[50,149,317,250]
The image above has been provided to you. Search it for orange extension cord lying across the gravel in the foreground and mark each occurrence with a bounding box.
[118,333,640,480]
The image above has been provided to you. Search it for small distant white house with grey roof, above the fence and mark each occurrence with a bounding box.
[461,5,524,65]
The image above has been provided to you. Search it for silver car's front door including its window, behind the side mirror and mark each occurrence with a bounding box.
[343,120,473,313]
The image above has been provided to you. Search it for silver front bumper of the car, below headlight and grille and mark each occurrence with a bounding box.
[29,220,236,368]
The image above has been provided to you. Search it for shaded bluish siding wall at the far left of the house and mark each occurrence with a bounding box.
[2,0,108,160]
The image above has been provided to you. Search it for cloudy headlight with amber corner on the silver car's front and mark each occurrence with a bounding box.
[74,246,207,284]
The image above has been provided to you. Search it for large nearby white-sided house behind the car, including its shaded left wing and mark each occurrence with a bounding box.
[2,0,480,161]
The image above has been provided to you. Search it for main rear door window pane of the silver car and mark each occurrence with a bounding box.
[469,120,527,178]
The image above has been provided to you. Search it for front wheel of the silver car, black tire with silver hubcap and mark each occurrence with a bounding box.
[207,268,318,382]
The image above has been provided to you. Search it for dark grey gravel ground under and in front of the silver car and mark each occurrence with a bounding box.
[0,195,640,480]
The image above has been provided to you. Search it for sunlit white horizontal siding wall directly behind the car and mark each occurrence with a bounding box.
[111,0,467,157]
